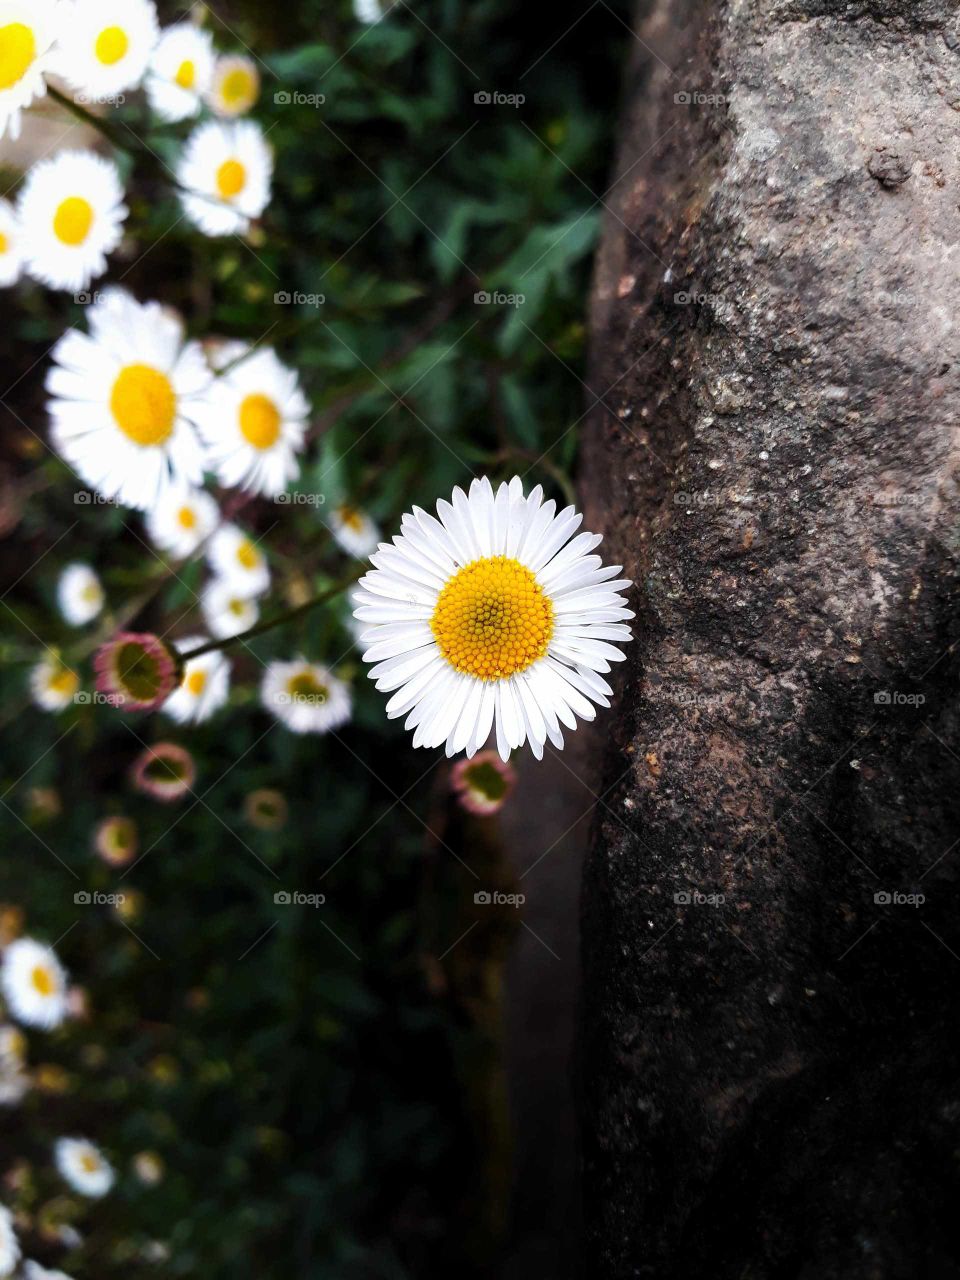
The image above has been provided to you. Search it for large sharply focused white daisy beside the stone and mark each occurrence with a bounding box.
[356,476,634,760]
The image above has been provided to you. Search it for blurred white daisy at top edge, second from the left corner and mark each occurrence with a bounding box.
[56,0,159,102]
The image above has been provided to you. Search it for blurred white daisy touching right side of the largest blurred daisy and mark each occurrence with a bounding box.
[197,347,310,498]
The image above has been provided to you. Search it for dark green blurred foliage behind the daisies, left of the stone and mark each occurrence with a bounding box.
[0,0,626,1280]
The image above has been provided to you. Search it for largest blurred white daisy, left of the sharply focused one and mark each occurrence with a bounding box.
[46,289,210,511]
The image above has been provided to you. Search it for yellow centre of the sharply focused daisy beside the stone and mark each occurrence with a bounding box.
[430,556,553,680]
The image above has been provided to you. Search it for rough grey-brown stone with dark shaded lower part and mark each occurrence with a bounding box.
[582,0,960,1280]
